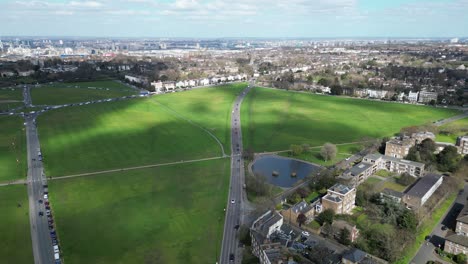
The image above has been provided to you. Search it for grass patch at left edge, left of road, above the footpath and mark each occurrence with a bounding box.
[0,116,28,182]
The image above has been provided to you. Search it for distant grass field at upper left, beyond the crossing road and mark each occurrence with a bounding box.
[31,81,137,105]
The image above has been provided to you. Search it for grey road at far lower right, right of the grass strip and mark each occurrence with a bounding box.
[411,184,468,264]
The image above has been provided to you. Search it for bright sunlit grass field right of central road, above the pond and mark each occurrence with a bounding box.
[242,88,458,152]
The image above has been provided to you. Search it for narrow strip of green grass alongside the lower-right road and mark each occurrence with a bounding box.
[396,194,457,264]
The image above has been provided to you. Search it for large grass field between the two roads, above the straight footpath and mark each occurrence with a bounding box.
[37,84,243,176]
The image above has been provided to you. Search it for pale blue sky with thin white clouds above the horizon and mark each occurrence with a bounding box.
[0,0,468,38]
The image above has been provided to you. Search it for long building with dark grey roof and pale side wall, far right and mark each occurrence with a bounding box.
[402,174,443,210]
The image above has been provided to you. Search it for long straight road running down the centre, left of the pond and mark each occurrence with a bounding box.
[219,81,254,264]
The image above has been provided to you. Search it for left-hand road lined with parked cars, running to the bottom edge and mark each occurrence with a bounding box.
[25,115,54,264]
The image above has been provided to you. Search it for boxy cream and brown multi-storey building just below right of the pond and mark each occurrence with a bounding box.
[322,183,356,214]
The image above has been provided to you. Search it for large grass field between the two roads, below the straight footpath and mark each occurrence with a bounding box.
[49,159,230,264]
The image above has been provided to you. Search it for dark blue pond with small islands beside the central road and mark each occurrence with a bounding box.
[252,155,320,188]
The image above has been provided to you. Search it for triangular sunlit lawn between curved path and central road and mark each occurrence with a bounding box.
[153,83,247,153]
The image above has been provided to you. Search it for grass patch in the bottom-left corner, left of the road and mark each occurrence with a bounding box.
[0,185,34,264]
